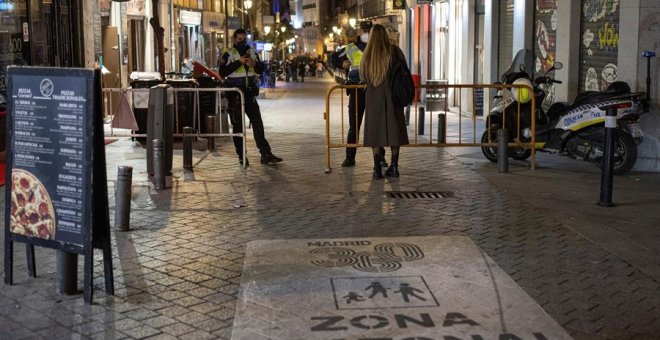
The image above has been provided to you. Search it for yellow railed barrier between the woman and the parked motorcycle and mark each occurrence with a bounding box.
[323,84,536,173]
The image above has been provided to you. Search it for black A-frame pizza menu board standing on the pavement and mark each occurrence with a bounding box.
[5,67,114,303]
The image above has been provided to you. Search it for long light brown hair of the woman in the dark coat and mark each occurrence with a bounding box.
[360,24,392,87]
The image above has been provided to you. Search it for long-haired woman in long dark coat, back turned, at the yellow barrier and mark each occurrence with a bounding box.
[360,24,408,179]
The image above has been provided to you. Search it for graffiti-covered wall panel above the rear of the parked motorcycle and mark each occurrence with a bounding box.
[579,0,619,92]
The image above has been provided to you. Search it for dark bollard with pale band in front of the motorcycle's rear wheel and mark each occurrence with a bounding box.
[598,106,616,207]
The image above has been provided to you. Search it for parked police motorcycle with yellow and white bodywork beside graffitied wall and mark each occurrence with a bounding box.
[481,49,643,175]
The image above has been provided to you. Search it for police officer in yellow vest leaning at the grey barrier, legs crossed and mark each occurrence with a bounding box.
[218,28,282,166]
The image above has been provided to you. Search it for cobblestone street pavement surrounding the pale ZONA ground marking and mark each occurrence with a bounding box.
[0,79,660,339]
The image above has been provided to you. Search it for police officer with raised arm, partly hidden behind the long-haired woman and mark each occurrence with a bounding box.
[330,21,387,167]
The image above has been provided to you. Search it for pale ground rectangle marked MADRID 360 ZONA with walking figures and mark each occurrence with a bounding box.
[232,236,570,339]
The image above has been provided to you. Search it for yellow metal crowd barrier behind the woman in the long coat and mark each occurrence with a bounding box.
[324,83,537,173]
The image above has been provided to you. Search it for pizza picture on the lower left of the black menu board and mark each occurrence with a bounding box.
[9,169,55,240]
